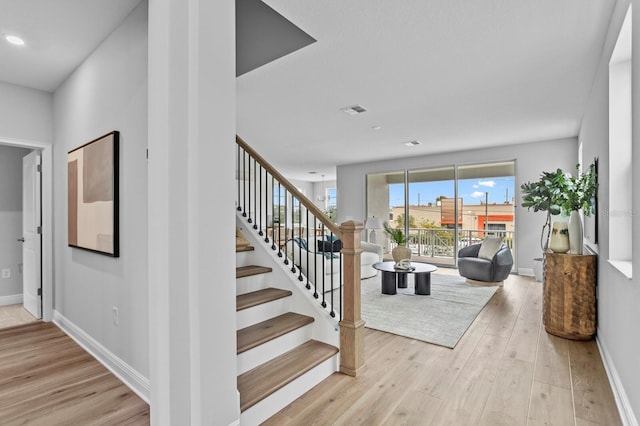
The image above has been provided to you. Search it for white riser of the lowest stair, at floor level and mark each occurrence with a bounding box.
[240,355,338,425]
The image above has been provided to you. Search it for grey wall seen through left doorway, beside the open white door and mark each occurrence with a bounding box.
[0,145,30,302]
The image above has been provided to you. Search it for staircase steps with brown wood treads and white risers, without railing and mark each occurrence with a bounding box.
[236,231,338,425]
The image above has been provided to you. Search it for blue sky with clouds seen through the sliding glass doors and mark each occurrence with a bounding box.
[389,176,515,207]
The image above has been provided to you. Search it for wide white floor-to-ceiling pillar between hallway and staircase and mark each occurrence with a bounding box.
[149,0,240,425]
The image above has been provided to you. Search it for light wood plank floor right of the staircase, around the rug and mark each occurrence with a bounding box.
[265,269,621,426]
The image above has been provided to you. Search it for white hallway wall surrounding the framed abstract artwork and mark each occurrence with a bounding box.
[53,2,149,377]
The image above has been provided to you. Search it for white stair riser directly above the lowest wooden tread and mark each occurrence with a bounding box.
[236,323,313,375]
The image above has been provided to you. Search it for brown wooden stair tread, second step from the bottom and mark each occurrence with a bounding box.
[236,312,314,354]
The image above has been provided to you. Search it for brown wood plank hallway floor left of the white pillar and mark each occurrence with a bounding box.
[0,321,149,426]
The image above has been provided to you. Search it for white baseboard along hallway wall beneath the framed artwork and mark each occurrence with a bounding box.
[53,311,151,404]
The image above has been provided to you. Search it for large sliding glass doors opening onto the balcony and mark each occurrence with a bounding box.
[367,162,515,265]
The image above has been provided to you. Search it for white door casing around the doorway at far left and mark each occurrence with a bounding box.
[0,136,53,321]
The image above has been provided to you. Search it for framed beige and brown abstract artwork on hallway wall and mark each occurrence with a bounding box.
[67,131,120,257]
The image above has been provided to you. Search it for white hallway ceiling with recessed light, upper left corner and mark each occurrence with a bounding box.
[0,0,140,92]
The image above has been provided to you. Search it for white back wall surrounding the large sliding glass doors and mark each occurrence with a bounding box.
[337,138,578,271]
